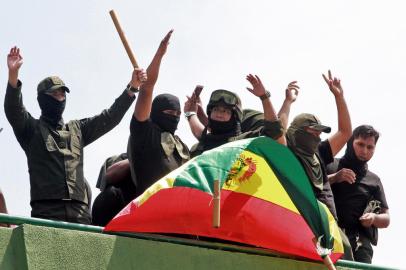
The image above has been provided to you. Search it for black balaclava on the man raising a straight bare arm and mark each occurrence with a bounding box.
[151,94,180,134]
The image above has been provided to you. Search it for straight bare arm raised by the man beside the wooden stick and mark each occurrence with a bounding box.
[134,30,173,122]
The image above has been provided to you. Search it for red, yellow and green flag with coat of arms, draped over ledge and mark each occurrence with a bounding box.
[105,137,343,262]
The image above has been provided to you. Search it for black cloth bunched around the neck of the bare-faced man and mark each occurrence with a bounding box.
[338,135,368,180]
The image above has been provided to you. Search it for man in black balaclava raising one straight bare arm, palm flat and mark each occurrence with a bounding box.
[127,30,189,196]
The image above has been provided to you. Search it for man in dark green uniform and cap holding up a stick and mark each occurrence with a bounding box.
[4,47,146,224]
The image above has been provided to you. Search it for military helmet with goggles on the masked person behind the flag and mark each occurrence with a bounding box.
[206,89,243,122]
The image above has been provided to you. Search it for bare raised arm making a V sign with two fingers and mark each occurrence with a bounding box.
[322,70,352,156]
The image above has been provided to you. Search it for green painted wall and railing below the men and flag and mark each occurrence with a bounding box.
[0,214,400,270]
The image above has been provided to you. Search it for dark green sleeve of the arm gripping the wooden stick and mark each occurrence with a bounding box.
[80,90,135,146]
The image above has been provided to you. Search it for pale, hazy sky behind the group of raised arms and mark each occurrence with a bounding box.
[0,0,406,268]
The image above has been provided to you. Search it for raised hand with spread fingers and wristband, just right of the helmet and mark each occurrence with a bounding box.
[246,74,286,145]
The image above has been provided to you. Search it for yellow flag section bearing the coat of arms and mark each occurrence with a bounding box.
[222,151,299,214]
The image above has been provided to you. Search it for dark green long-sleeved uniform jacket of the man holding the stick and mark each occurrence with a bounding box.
[4,81,134,204]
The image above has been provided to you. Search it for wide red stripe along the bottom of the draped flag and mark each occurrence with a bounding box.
[105,187,342,262]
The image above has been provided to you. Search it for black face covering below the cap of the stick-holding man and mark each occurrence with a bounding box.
[37,93,66,127]
